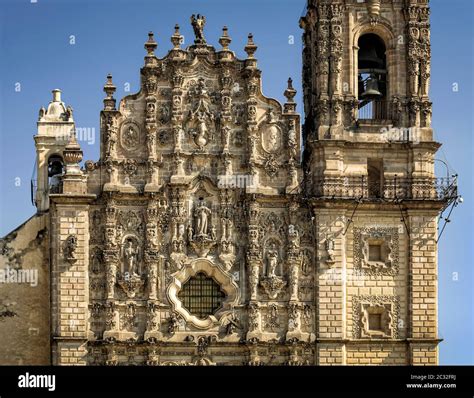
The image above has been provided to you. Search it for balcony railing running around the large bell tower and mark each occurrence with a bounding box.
[311,176,458,202]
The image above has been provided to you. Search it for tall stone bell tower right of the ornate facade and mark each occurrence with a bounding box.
[300,0,457,365]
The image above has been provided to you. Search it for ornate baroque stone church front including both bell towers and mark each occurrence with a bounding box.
[0,0,456,366]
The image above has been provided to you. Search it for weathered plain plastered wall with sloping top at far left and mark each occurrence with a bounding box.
[0,214,51,365]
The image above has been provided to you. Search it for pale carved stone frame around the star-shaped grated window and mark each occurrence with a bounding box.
[167,259,240,330]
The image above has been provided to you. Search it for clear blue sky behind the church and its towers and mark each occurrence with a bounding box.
[0,0,474,364]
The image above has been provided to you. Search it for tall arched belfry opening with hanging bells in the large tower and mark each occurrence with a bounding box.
[357,33,387,120]
